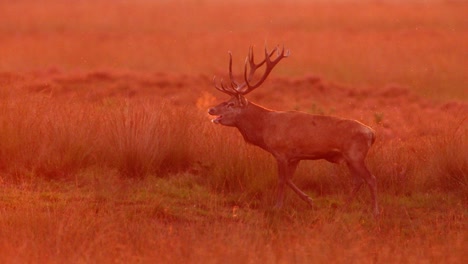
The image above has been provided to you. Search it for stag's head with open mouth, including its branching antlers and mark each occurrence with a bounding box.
[208,46,290,126]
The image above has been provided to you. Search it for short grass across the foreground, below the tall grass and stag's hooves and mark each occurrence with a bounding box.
[0,175,467,263]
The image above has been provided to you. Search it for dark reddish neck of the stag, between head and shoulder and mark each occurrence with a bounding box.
[236,102,271,148]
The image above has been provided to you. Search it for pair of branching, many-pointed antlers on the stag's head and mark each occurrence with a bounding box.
[213,46,291,95]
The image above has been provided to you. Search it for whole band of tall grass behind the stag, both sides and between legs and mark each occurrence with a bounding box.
[0,86,468,206]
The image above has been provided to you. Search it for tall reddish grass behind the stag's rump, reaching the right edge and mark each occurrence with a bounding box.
[369,127,468,200]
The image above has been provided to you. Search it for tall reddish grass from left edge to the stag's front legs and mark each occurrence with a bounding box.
[0,91,271,194]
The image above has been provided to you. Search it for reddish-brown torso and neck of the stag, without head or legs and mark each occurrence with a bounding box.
[214,102,374,163]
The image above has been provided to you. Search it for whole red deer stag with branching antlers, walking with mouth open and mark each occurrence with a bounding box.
[208,47,379,216]
